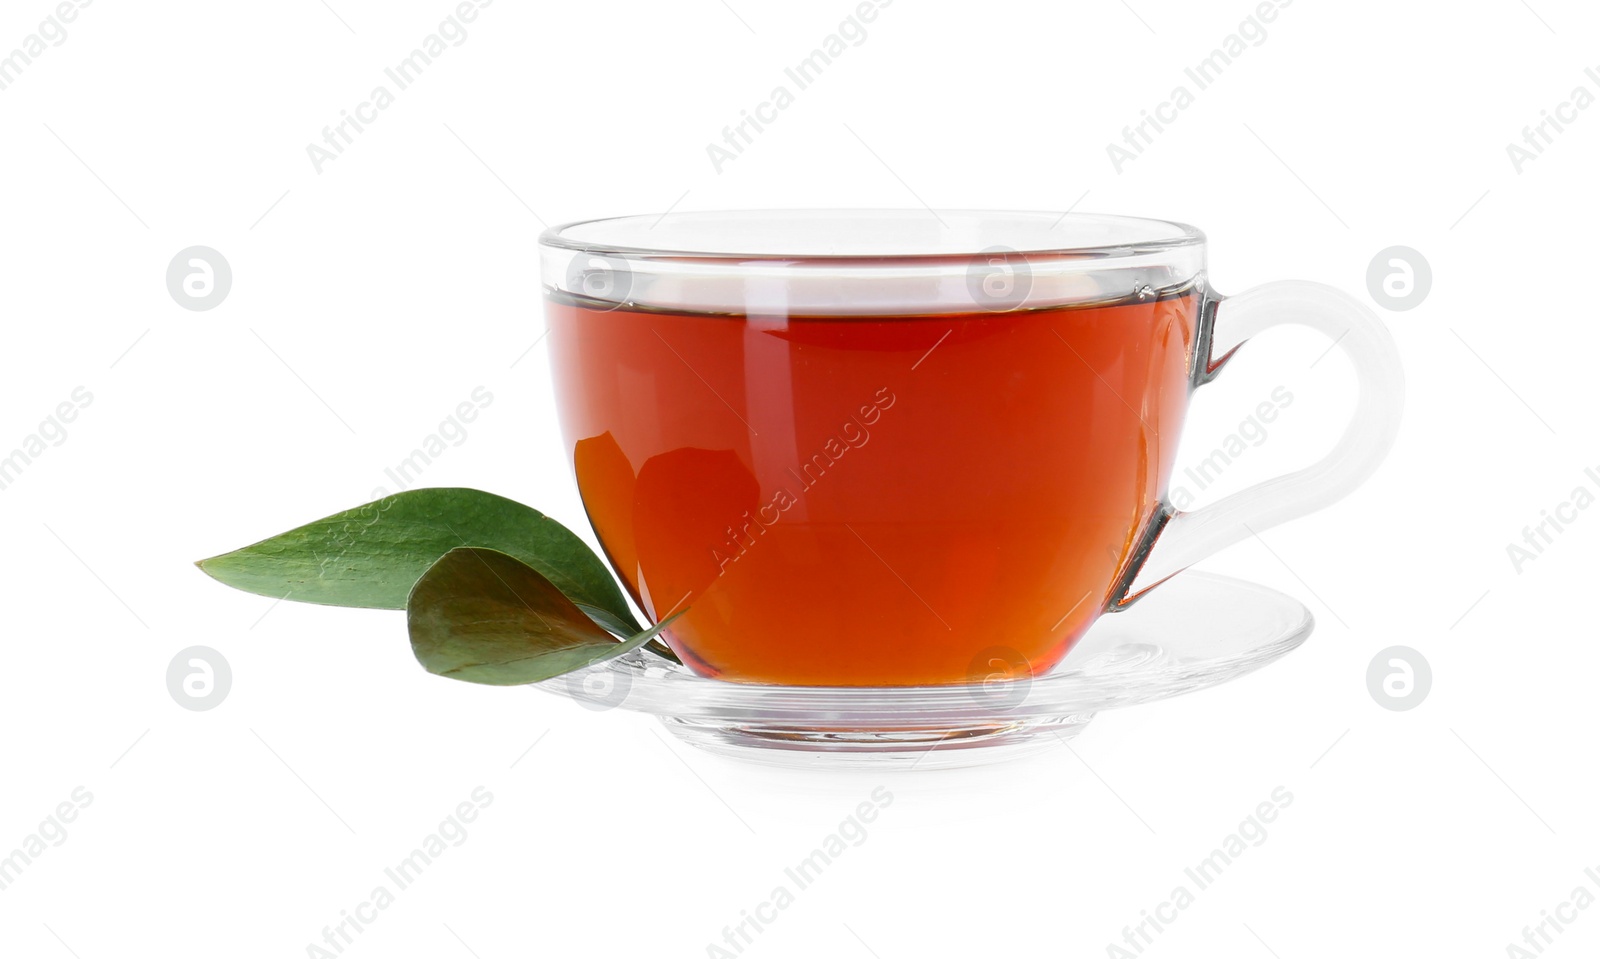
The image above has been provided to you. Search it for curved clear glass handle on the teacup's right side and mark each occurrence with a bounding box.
[1112,280,1405,608]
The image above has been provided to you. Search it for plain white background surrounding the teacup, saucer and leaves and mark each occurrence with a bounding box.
[0,0,1600,959]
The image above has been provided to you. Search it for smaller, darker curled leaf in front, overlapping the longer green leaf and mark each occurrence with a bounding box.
[405,548,675,685]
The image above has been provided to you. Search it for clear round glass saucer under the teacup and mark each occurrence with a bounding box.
[536,572,1312,768]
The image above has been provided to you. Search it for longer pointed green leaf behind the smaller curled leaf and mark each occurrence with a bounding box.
[197,488,642,636]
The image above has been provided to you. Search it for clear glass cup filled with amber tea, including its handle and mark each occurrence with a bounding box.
[539,210,1403,688]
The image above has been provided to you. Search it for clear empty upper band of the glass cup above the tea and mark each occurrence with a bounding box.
[539,210,1205,317]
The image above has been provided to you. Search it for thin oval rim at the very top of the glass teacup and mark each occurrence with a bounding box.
[539,208,1205,264]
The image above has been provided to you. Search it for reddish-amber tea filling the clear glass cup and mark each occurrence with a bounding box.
[547,291,1198,685]
